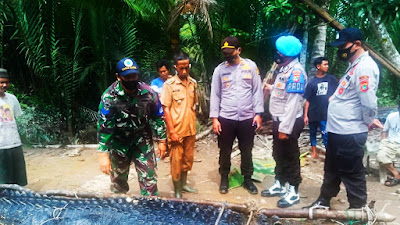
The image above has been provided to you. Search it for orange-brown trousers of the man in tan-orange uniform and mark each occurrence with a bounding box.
[170,135,196,181]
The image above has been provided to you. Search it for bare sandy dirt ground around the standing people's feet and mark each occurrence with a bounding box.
[24,135,400,224]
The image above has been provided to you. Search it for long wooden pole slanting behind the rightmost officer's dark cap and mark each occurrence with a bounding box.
[299,0,400,77]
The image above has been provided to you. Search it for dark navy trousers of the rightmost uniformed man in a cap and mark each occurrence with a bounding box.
[320,132,368,208]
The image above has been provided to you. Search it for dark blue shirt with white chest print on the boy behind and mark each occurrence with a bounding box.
[304,74,338,122]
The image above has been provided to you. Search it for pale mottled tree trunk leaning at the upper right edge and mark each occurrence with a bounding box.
[369,13,400,67]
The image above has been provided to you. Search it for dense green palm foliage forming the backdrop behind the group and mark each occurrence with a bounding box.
[0,0,400,143]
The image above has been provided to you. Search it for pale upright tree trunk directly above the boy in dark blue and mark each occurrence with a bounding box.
[308,0,330,77]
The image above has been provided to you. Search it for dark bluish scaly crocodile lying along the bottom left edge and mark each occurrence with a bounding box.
[0,185,246,225]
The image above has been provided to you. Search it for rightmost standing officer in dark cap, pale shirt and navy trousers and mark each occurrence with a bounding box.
[312,28,379,209]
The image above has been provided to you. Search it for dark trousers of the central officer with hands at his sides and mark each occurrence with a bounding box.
[218,117,255,178]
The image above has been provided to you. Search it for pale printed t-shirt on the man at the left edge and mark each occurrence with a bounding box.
[0,93,22,149]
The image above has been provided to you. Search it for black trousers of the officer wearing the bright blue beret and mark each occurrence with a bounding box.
[272,117,304,186]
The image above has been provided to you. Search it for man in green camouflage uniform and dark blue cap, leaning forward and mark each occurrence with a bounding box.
[98,58,166,195]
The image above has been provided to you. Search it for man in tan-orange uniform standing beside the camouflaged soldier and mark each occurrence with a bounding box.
[161,52,197,198]
